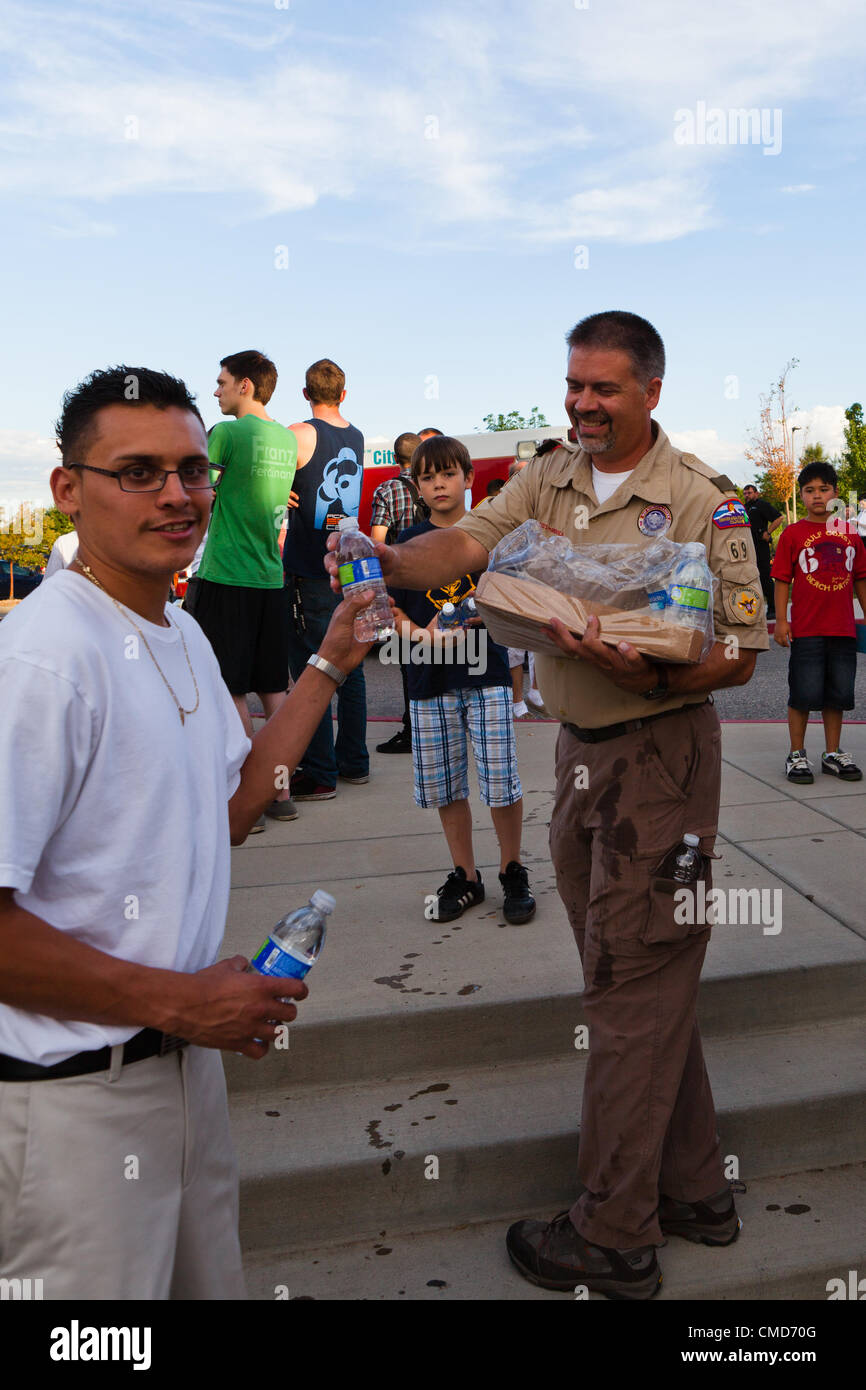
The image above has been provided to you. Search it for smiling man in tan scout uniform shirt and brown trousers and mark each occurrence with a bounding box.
[328,311,769,1298]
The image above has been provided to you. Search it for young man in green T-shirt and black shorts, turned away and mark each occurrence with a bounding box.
[185,350,297,830]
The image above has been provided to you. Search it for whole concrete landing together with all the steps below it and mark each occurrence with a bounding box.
[224,721,866,1300]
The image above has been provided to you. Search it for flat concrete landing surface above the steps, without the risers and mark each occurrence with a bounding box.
[224,723,866,1050]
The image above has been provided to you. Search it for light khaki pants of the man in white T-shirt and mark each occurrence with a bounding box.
[0,1047,246,1300]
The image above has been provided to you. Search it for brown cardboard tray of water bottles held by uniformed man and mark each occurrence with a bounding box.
[474,570,703,663]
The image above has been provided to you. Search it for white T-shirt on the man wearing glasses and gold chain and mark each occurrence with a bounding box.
[0,570,250,1066]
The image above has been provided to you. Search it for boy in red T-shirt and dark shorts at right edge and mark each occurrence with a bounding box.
[770,463,866,783]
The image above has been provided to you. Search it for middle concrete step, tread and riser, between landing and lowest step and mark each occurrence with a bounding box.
[232,1019,866,1250]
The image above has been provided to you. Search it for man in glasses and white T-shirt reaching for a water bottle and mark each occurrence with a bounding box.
[0,367,368,1298]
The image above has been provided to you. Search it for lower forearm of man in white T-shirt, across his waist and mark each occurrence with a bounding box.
[0,897,188,1033]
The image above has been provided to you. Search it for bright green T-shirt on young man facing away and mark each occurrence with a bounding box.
[199,416,297,589]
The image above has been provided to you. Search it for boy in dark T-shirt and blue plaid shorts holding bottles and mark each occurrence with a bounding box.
[392,435,535,924]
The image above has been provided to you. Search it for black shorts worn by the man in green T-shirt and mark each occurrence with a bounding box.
[183,580,289,695]
